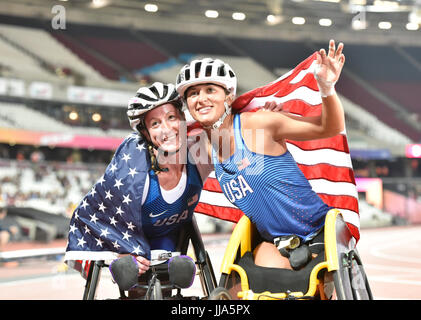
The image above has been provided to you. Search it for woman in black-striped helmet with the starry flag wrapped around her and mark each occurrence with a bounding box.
[65,82,213,274]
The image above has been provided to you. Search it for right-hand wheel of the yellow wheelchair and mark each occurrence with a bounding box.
[333,250,373,300]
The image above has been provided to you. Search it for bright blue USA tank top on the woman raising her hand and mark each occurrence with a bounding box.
[212,114,330,241]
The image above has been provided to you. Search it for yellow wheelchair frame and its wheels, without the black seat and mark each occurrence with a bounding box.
[212,209,372,300]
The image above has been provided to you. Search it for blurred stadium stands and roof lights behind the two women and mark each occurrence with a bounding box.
[0,0,421,296]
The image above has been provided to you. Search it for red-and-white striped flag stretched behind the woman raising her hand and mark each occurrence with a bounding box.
[191,53,360,240]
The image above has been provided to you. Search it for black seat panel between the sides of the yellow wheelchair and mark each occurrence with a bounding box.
[238,251,325,294]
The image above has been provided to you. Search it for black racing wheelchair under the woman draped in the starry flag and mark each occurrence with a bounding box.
[83,216,217,300]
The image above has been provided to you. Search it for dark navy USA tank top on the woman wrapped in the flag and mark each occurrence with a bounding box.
[142,162,203,251]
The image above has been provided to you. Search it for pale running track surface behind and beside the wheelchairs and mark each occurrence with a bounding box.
[0,226,421,300]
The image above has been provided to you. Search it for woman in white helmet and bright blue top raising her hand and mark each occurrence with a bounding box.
[176,40,345,268]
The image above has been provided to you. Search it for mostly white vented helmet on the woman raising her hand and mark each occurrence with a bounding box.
[176,58,237,97]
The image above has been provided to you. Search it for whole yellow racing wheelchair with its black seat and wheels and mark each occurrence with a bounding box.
[209,209,373,300]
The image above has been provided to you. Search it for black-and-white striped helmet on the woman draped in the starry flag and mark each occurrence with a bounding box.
[127,82,182,132]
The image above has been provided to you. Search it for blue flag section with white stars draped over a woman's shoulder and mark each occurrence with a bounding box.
[64,134,150,268]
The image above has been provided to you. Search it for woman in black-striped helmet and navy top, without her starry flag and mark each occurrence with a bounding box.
[127,82,212,269]
